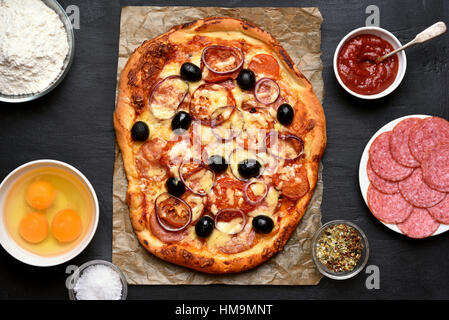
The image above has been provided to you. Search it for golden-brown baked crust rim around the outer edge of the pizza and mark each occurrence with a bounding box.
[114,17,326,273]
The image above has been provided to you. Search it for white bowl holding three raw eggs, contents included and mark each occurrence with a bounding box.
[0,160,99,267]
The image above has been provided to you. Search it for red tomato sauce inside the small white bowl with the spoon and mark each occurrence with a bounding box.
[337,34,399,95]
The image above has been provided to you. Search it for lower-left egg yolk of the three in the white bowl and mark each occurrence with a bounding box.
[19,212,48,243]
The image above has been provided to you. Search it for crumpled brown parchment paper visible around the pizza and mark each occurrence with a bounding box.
[112,7,324,285]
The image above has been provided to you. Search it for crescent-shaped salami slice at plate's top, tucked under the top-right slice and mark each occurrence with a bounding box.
[390,118,422,168]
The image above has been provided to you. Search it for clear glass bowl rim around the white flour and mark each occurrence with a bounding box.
[0,0,75,103]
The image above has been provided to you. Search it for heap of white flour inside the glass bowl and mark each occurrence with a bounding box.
[0,0,69,95]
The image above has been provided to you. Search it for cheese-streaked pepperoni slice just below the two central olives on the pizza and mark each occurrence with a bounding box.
[208,176,254,213]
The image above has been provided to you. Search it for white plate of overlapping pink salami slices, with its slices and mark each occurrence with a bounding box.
[359,115,449,239]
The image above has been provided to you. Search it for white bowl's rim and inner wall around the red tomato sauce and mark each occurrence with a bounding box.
[334,27,407,99]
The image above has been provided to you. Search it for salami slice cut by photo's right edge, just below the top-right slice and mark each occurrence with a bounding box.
[422,143,449,192]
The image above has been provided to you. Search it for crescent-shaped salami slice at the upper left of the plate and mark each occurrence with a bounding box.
[369,131,413,181]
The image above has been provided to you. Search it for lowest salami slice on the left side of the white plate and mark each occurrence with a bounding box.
[368,185,413,223]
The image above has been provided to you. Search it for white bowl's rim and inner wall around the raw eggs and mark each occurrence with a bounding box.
[0,160,100,267]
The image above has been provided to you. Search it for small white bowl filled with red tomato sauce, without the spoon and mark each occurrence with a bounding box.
[334,27,407,99]
